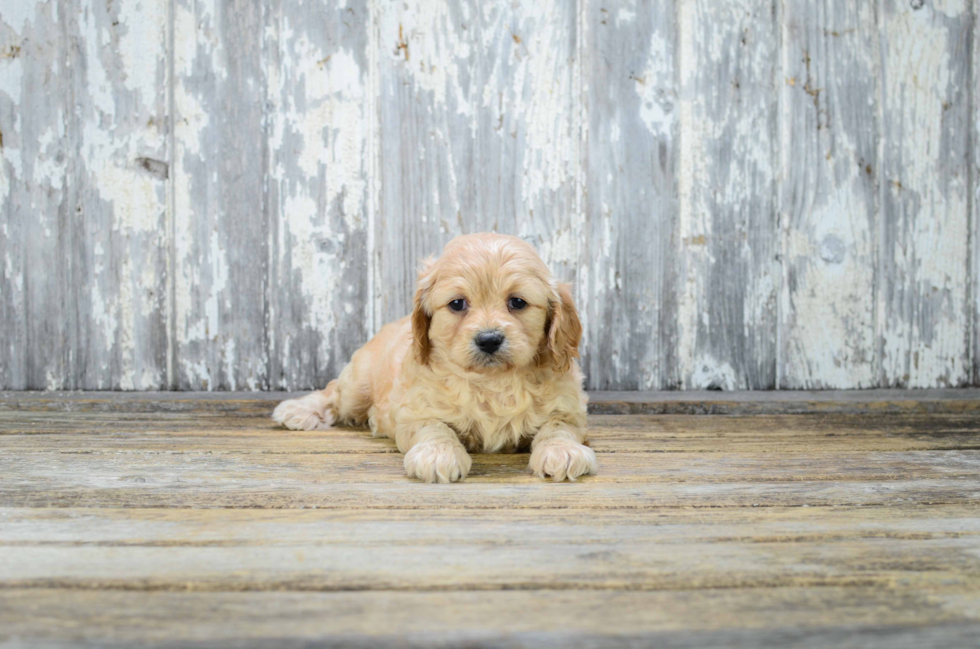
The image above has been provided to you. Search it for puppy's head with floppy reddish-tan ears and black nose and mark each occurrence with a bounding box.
[412,234,582,372]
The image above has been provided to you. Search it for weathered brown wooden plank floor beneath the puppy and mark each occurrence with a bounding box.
[0,391,980,648]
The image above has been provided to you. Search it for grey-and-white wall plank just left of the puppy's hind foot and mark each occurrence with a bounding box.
[171,0,270,390]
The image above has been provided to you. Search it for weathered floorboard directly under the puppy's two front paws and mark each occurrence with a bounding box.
[0,448,980,492]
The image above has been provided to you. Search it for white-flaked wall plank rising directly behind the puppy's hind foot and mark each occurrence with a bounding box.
[267,0,376,390]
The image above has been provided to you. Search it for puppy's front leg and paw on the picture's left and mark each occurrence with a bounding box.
[395,421,473,483]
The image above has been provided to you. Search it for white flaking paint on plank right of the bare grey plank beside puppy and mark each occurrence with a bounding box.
[676,0,778,389]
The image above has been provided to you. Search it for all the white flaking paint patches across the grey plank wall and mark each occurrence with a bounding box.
[0,0,980,389]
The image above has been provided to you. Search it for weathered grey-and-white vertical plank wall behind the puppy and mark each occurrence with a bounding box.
[0,0,980,390]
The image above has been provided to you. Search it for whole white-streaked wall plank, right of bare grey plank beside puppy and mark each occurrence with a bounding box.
[666,0,781,390]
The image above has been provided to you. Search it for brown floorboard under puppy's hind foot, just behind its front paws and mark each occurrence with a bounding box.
[0,411,980,450]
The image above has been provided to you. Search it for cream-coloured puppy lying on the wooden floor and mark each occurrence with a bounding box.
[272,234,596,482]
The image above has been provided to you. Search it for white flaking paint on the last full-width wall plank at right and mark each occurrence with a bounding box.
[879,2,969,387]
